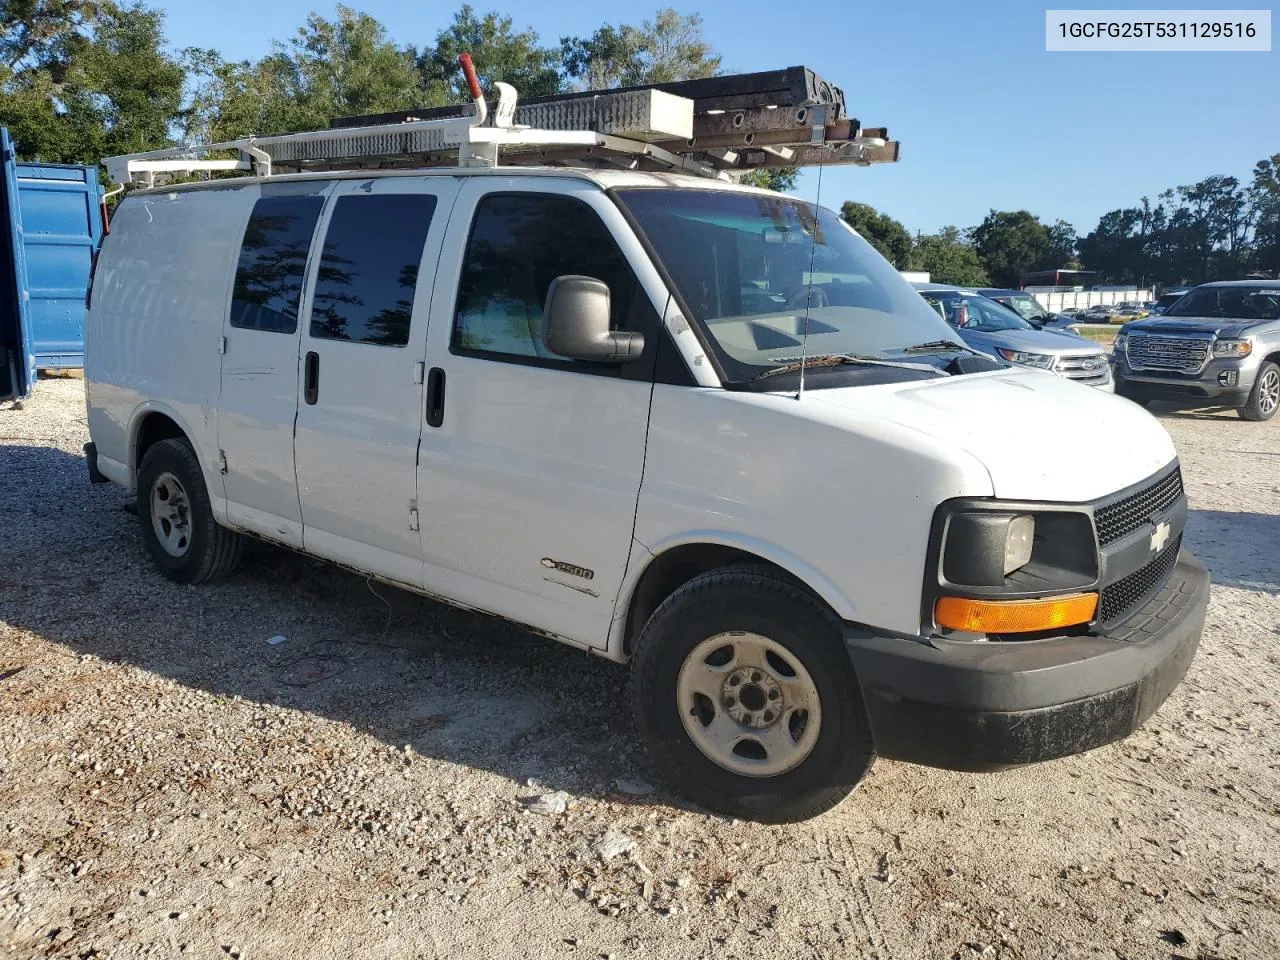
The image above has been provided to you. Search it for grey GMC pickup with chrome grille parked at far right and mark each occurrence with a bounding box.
[1111,280,1280,420]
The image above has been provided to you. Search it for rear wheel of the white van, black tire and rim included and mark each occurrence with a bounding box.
[137,439,243,584]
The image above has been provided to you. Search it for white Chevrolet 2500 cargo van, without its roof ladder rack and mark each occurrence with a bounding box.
[86,64,1207,820]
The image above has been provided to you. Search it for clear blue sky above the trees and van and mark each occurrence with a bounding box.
[152,0,1280,234]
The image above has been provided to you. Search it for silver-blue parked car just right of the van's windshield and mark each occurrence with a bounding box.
[911,283,1115,390]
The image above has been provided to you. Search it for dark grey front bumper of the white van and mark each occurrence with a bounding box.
[845,550,1208,771]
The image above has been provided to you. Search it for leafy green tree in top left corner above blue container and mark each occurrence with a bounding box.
[0,0,183,163]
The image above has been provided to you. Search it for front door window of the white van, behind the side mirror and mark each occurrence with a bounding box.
[452,193,644,364]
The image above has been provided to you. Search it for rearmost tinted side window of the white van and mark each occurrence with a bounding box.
[230,196,324,333]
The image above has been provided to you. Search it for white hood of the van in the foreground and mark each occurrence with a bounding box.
[805,370,1176,503]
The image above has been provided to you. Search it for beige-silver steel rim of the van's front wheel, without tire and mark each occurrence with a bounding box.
[676,631,822,777]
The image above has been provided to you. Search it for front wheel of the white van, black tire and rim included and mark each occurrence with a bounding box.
[632,564,876,823]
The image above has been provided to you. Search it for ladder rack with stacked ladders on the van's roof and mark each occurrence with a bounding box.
[104,54,899,187]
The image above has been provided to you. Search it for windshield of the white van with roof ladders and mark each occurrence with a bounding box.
[617,188,954,381]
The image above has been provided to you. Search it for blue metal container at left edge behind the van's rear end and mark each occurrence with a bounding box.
[0,128,102,399]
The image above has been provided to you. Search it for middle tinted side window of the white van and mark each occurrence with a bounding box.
[311,193,435,347]
